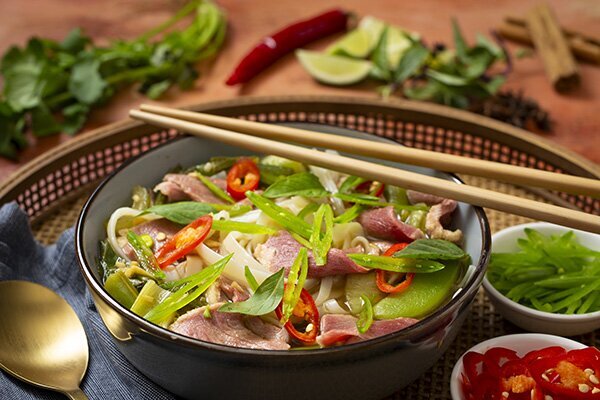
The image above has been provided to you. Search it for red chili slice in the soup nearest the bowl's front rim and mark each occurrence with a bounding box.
[275,289,319,345]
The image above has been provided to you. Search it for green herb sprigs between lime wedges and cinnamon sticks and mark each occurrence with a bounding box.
[372,20,507,108]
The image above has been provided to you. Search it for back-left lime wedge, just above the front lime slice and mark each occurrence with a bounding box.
[325,16,385,58]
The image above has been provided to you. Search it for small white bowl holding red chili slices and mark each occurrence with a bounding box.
[450,333,587,400]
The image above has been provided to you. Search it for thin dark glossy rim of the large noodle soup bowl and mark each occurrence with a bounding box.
[75,126,491,358]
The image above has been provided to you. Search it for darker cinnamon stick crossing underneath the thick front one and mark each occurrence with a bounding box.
[498,16,600,65]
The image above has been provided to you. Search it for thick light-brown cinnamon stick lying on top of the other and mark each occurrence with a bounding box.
[526,4,580,92]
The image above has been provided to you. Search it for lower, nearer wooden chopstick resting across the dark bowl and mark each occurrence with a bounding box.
[129,110,600,233]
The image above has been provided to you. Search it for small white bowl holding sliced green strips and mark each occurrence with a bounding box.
[483,222,600,336]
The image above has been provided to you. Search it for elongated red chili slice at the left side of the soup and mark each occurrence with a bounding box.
[155,215,212,269]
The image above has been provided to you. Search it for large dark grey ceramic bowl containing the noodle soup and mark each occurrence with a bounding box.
[76,124,490,400]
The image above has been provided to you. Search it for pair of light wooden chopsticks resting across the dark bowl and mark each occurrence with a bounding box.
[129,105,600,233]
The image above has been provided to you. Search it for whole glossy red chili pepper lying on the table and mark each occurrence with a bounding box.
[225,9,348,86]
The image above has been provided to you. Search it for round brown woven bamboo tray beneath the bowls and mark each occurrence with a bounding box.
[0,96,600,400]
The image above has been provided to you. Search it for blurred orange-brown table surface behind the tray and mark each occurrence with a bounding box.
[0,0,600,180]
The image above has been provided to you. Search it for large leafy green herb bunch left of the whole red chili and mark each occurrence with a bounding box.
[0,0,227,158]
